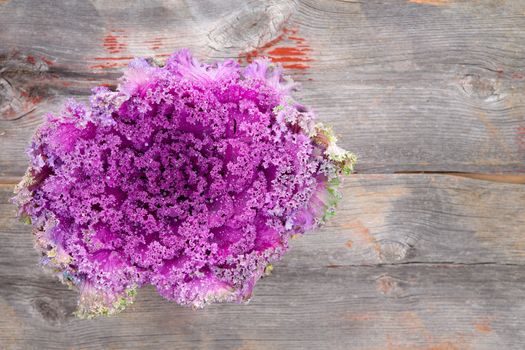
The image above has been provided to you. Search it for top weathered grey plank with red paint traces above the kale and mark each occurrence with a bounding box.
[0,0,525,177]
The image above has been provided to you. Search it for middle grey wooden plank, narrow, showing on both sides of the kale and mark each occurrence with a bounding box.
[0,174,525,268]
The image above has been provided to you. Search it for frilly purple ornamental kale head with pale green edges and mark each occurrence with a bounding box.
[14,50,355,317]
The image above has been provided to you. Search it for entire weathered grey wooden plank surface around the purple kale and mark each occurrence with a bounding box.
[0,0,525,350]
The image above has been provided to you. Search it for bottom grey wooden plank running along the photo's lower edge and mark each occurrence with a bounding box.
[0,264,525,350]
